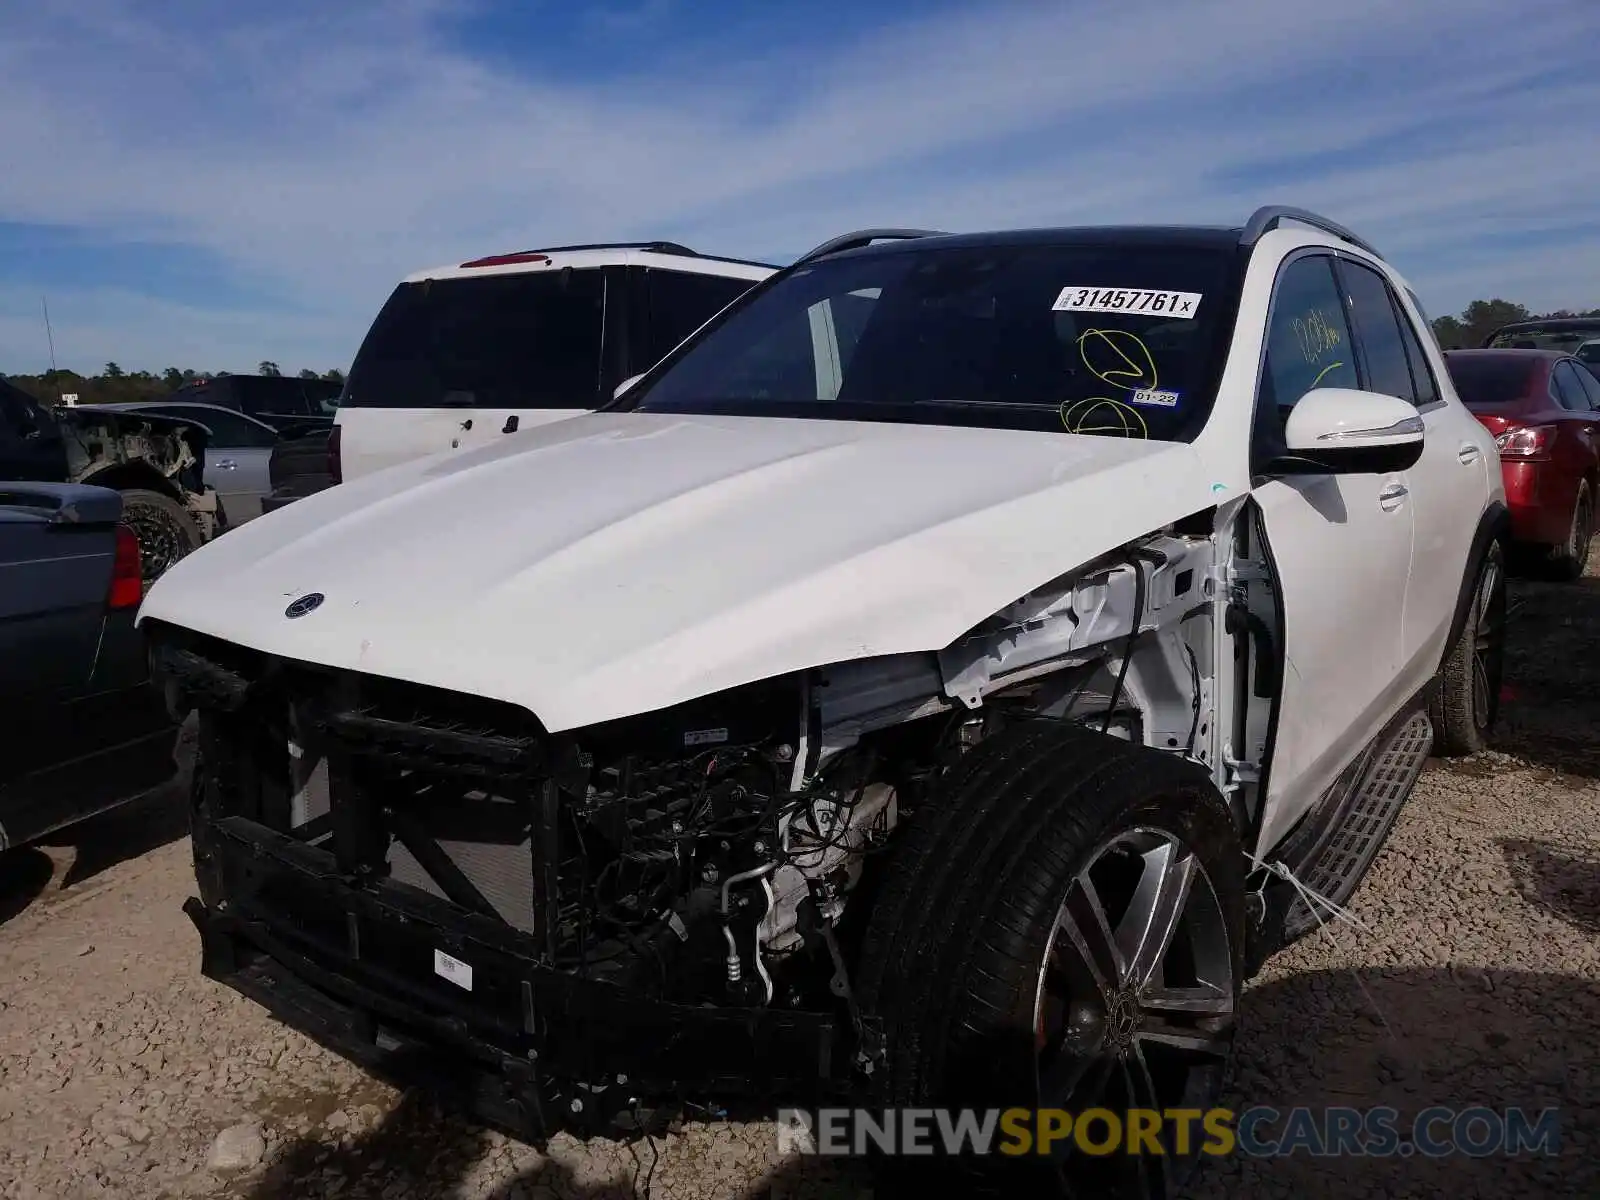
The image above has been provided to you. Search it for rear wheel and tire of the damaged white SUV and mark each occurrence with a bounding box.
[1427,541,1506,758]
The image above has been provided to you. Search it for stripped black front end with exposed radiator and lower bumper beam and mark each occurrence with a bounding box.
[152,626,853,1141]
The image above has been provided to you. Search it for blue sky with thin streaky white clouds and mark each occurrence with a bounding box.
[0,0,1600,373]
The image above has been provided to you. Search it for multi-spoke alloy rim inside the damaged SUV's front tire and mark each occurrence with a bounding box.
[1034,829,1237,1197]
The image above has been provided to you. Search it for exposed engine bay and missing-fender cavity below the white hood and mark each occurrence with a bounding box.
[152,509,1278,1126]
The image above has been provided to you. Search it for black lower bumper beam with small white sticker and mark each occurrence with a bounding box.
[184,818,837,1141]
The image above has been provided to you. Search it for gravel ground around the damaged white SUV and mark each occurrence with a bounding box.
[0,550,1600,1200]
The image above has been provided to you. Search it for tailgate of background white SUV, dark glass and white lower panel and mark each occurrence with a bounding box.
[338,267,608,478]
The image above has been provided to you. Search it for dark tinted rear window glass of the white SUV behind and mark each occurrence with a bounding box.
[339,269,605,408]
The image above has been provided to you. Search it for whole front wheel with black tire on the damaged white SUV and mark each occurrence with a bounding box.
[861,722,1245,1197]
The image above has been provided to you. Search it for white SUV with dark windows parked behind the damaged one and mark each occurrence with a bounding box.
[330,242,776,482]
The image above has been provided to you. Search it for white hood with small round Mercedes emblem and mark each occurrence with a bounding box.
[139,413,1213,731]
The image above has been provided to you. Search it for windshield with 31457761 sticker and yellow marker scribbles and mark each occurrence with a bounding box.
[618,242,1235,440]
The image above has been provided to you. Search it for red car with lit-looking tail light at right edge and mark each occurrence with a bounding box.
[1445,350,1600,579]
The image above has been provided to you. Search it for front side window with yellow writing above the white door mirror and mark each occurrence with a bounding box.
[1258,254,1360,418]
